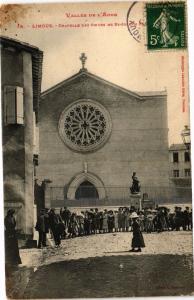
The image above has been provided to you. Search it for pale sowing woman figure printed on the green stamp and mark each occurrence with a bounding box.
[153,8,180,47]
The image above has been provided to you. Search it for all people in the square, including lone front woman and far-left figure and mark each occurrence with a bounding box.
[4,206,193,266]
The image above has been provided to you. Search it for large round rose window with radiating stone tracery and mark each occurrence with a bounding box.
[59,100,111,151]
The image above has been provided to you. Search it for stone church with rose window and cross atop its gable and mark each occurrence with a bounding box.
[37,53,170,208]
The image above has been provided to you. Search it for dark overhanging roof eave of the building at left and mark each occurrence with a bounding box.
[0,36,43,117]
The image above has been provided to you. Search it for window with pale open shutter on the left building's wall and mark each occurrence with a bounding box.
[4,86,24,125]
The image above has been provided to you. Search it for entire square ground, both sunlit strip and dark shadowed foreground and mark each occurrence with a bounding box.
[6,231,193,299]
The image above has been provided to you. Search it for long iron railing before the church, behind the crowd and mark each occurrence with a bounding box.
[48,186,192,207]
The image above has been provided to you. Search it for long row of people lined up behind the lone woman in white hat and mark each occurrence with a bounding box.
[36,206,192,248]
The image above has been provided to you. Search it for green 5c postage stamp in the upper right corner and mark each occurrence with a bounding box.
[146,2,187,50]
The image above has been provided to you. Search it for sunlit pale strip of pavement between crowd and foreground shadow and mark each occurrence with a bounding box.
[20,231,192,267]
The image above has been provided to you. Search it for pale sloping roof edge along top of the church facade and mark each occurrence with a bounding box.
[41,68,167,100]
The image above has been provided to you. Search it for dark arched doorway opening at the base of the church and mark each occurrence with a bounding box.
[75,180,99,200]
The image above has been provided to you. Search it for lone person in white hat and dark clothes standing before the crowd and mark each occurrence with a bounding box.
[129,212,145,252]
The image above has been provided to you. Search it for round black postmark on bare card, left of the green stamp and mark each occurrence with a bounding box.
[127,1,145,43]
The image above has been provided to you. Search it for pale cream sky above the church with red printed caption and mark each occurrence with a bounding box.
[2,2,189,144]
